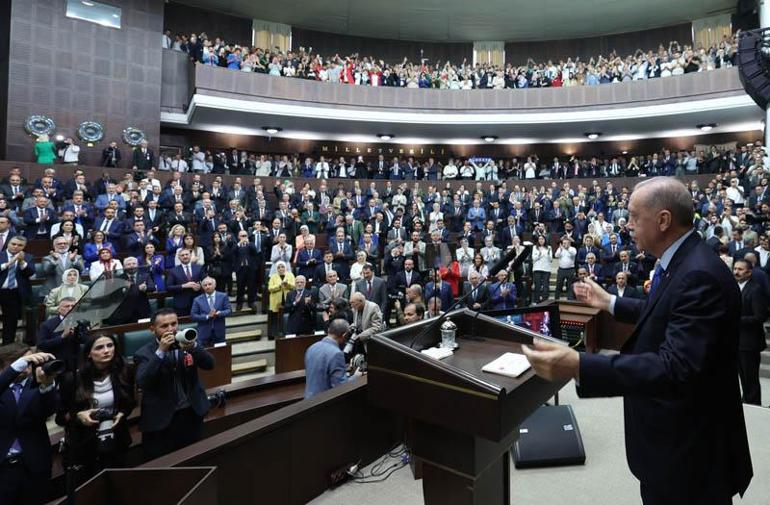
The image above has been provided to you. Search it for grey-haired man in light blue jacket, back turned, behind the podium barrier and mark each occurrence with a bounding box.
[305,319,360,398]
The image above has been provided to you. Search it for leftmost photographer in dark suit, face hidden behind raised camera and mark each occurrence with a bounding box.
[0,343,59,505]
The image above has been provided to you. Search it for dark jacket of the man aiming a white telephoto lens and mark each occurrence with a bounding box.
[134,341,214,432]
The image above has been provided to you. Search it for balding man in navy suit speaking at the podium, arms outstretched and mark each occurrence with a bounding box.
[524,177,753,505]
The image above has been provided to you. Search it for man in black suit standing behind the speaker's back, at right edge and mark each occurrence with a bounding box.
[733,259,768,405]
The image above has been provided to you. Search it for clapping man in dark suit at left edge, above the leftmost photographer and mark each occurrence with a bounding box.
[0,236,35,345]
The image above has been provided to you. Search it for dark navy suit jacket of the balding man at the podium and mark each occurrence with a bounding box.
[578,234,753,504]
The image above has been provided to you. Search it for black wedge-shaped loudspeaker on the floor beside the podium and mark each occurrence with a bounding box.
[511,405,586,468]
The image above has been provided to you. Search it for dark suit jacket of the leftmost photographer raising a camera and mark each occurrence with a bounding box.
[0,366,59,479]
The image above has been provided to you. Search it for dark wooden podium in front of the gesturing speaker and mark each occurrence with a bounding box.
[368,309,566,505]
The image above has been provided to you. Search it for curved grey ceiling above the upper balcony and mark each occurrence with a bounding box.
[180,0,736,42]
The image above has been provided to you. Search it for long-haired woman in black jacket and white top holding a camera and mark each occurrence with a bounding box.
[56,335,136,483]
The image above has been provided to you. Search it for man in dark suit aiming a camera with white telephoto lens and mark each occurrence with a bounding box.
[134,309,214,459]
